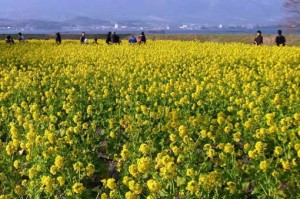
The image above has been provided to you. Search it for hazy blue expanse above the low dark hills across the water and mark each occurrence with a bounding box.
[0,0,284,25]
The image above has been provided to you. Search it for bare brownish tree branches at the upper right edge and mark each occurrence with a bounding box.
[284,0,300,27]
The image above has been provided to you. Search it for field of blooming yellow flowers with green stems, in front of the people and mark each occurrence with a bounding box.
[0,40,300,199]
